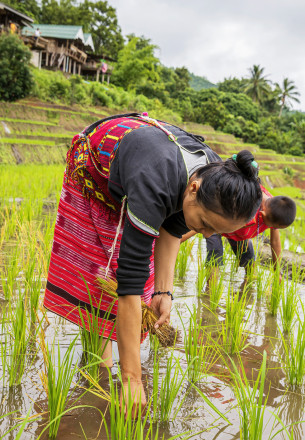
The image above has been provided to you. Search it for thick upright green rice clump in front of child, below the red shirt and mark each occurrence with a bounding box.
[220,286,253,354]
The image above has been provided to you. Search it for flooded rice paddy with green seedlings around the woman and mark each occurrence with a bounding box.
[0,166,305,440]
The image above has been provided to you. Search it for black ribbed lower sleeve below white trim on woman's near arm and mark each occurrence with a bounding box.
[116,216,154,296]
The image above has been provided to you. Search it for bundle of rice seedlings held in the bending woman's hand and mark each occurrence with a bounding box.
[97,276,177,347]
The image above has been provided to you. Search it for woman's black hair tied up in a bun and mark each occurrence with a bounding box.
[196,150,262,223]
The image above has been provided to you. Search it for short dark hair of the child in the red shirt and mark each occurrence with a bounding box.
[267,196,297,227]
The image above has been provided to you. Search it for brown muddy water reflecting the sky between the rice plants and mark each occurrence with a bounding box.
[0,239,305,440]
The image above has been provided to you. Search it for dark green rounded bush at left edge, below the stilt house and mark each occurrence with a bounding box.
[0,34,33,101]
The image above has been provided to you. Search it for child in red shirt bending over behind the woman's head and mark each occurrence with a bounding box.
[181,185,296,292]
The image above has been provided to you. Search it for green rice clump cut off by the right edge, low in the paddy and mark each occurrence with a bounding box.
[280,312,305,386]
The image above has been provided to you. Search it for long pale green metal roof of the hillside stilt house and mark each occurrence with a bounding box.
[22,23,85,44]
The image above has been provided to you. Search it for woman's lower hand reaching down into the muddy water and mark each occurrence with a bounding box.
[120,378,147,419]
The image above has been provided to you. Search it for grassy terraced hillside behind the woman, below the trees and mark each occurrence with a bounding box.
[0,100,305,194]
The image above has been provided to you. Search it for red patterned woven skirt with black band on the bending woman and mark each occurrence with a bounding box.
[44,116,154,341]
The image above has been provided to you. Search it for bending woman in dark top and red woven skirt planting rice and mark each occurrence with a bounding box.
[44,114,262,412]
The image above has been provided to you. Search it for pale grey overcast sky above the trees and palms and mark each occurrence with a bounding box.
[108,0,305,111]
